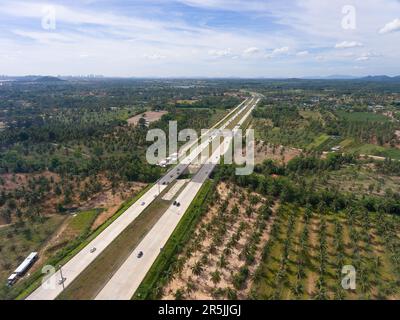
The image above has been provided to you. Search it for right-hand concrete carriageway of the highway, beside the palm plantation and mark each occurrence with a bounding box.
[96,95,259,300]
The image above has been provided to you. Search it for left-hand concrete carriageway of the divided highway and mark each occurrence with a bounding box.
[26,97,254,300]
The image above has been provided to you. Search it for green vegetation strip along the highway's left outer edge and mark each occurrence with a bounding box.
[15,183,154,300]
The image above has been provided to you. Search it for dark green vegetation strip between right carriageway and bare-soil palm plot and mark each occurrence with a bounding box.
[133,180,216,300]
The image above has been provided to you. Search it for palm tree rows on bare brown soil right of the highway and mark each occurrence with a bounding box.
[170,187,272,299]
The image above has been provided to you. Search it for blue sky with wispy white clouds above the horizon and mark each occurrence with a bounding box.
[0,0,400,77]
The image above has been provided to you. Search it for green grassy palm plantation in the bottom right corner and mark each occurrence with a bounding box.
[251,206,400,299]
